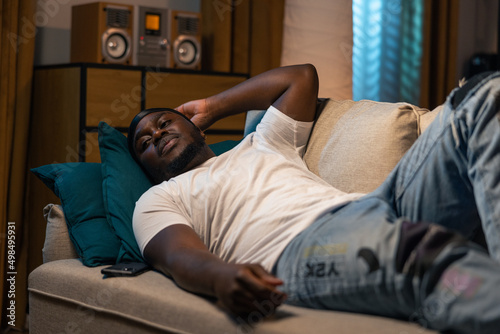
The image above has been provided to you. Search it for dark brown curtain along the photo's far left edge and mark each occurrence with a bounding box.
[0,0,36,329]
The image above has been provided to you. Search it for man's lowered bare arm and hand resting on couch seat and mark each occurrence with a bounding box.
[144,225,286,313]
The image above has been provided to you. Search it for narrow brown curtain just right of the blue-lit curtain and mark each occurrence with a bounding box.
[419,0,460,109]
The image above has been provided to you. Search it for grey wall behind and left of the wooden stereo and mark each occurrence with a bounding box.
[35,0,200,65]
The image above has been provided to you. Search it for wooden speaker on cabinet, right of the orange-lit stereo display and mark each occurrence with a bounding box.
[170,10,201,70]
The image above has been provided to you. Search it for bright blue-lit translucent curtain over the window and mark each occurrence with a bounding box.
[352,0,424,104]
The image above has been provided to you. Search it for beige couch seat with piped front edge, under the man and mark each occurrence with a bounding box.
[29,259,434,334]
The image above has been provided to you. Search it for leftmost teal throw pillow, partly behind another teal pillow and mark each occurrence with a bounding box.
[31,162,120,267]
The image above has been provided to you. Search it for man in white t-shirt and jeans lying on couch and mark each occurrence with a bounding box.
[128,65,500,333]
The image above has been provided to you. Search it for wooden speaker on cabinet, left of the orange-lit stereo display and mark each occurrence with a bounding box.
[70,2,134,65]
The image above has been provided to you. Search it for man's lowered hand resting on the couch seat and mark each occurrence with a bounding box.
[214,264,286,316]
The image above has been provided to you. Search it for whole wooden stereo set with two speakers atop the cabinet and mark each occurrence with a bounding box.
[71,2,202,70]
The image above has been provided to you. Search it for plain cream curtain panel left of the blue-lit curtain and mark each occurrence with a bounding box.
[281,0,352,99]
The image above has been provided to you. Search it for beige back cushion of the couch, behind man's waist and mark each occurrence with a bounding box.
[304,100,434,193]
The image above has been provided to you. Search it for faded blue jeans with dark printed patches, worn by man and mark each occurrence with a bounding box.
[275,73,500,333]
